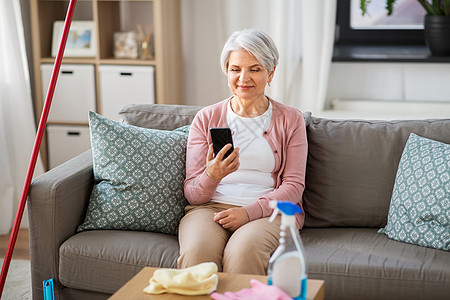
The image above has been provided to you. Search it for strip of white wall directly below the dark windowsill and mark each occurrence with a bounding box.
[327,62,450,104]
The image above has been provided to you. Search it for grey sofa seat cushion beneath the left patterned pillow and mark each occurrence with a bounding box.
[59,230,179,294]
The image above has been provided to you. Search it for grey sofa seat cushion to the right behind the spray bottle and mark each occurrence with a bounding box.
[301,228,450,300]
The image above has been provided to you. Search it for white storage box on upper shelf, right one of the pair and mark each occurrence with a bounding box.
[99,65,155,120]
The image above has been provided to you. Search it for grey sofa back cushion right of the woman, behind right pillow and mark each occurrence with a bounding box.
[303,117,450,228]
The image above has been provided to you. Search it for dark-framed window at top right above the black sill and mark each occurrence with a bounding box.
[336,0,425,45]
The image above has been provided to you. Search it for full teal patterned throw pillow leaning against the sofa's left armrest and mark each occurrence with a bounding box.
[78,112,189,235]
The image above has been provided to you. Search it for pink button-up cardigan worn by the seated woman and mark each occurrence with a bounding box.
[184,98,308,229]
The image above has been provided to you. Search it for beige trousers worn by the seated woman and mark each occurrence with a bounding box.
[178,202,281,275]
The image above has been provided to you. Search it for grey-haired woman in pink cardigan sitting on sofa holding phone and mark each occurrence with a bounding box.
[178,29,307,275]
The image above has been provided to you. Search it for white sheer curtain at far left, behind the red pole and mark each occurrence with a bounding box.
[0,0,43,234]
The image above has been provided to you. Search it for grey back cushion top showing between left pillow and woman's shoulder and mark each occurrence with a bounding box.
[119,104,202,130]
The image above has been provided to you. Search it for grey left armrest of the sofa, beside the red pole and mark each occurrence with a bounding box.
[27,150,94,299]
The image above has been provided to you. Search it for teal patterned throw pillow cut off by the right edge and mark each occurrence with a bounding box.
[378,133,450,251]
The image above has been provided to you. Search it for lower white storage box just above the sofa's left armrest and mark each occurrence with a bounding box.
[47,125,91,169]
